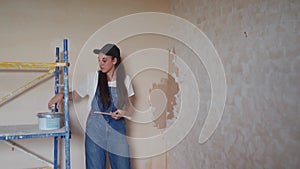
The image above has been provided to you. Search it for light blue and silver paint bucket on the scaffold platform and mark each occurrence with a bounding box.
[37,112,63,130]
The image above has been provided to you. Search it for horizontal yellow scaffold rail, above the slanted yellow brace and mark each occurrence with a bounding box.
[0,62,67,70]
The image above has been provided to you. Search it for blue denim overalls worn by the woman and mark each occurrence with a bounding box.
[85,87,131,169]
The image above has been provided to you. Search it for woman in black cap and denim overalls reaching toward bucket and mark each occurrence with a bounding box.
[48,44,134,169]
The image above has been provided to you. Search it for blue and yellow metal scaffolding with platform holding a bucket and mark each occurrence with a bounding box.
[0,39,70,169]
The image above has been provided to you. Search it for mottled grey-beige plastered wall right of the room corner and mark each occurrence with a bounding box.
[167,0,300,169]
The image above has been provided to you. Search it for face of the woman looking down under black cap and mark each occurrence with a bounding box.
[98,53,117,73]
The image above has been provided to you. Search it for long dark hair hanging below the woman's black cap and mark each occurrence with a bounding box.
[98,56,129,109]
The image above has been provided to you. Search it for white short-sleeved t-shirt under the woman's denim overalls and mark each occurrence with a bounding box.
[75,72,134,111]
